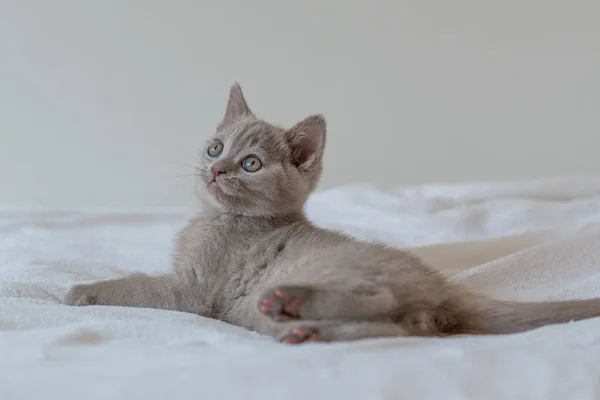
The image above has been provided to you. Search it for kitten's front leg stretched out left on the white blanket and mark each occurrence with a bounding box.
[64,274,210,316]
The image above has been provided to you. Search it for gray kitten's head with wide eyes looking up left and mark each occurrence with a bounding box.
[200,84,326,216]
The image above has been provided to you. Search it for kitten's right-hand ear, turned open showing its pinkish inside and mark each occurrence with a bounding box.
[285,115,327,170]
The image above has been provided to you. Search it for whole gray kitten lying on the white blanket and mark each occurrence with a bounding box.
[65,84,600,343]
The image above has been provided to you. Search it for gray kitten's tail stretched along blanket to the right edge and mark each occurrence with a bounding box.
[461,298,600,334]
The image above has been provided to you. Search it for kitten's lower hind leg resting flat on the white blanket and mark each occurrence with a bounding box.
[277,322,410,344]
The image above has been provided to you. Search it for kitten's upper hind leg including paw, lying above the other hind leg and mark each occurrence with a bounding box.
[257,285,398,322]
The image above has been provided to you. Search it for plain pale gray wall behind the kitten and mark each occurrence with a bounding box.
[0,0,600,207]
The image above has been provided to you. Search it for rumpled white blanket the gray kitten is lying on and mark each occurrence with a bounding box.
[0,178,600,400]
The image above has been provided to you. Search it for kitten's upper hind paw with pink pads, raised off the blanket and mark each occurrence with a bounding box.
[258,286,313,322]
